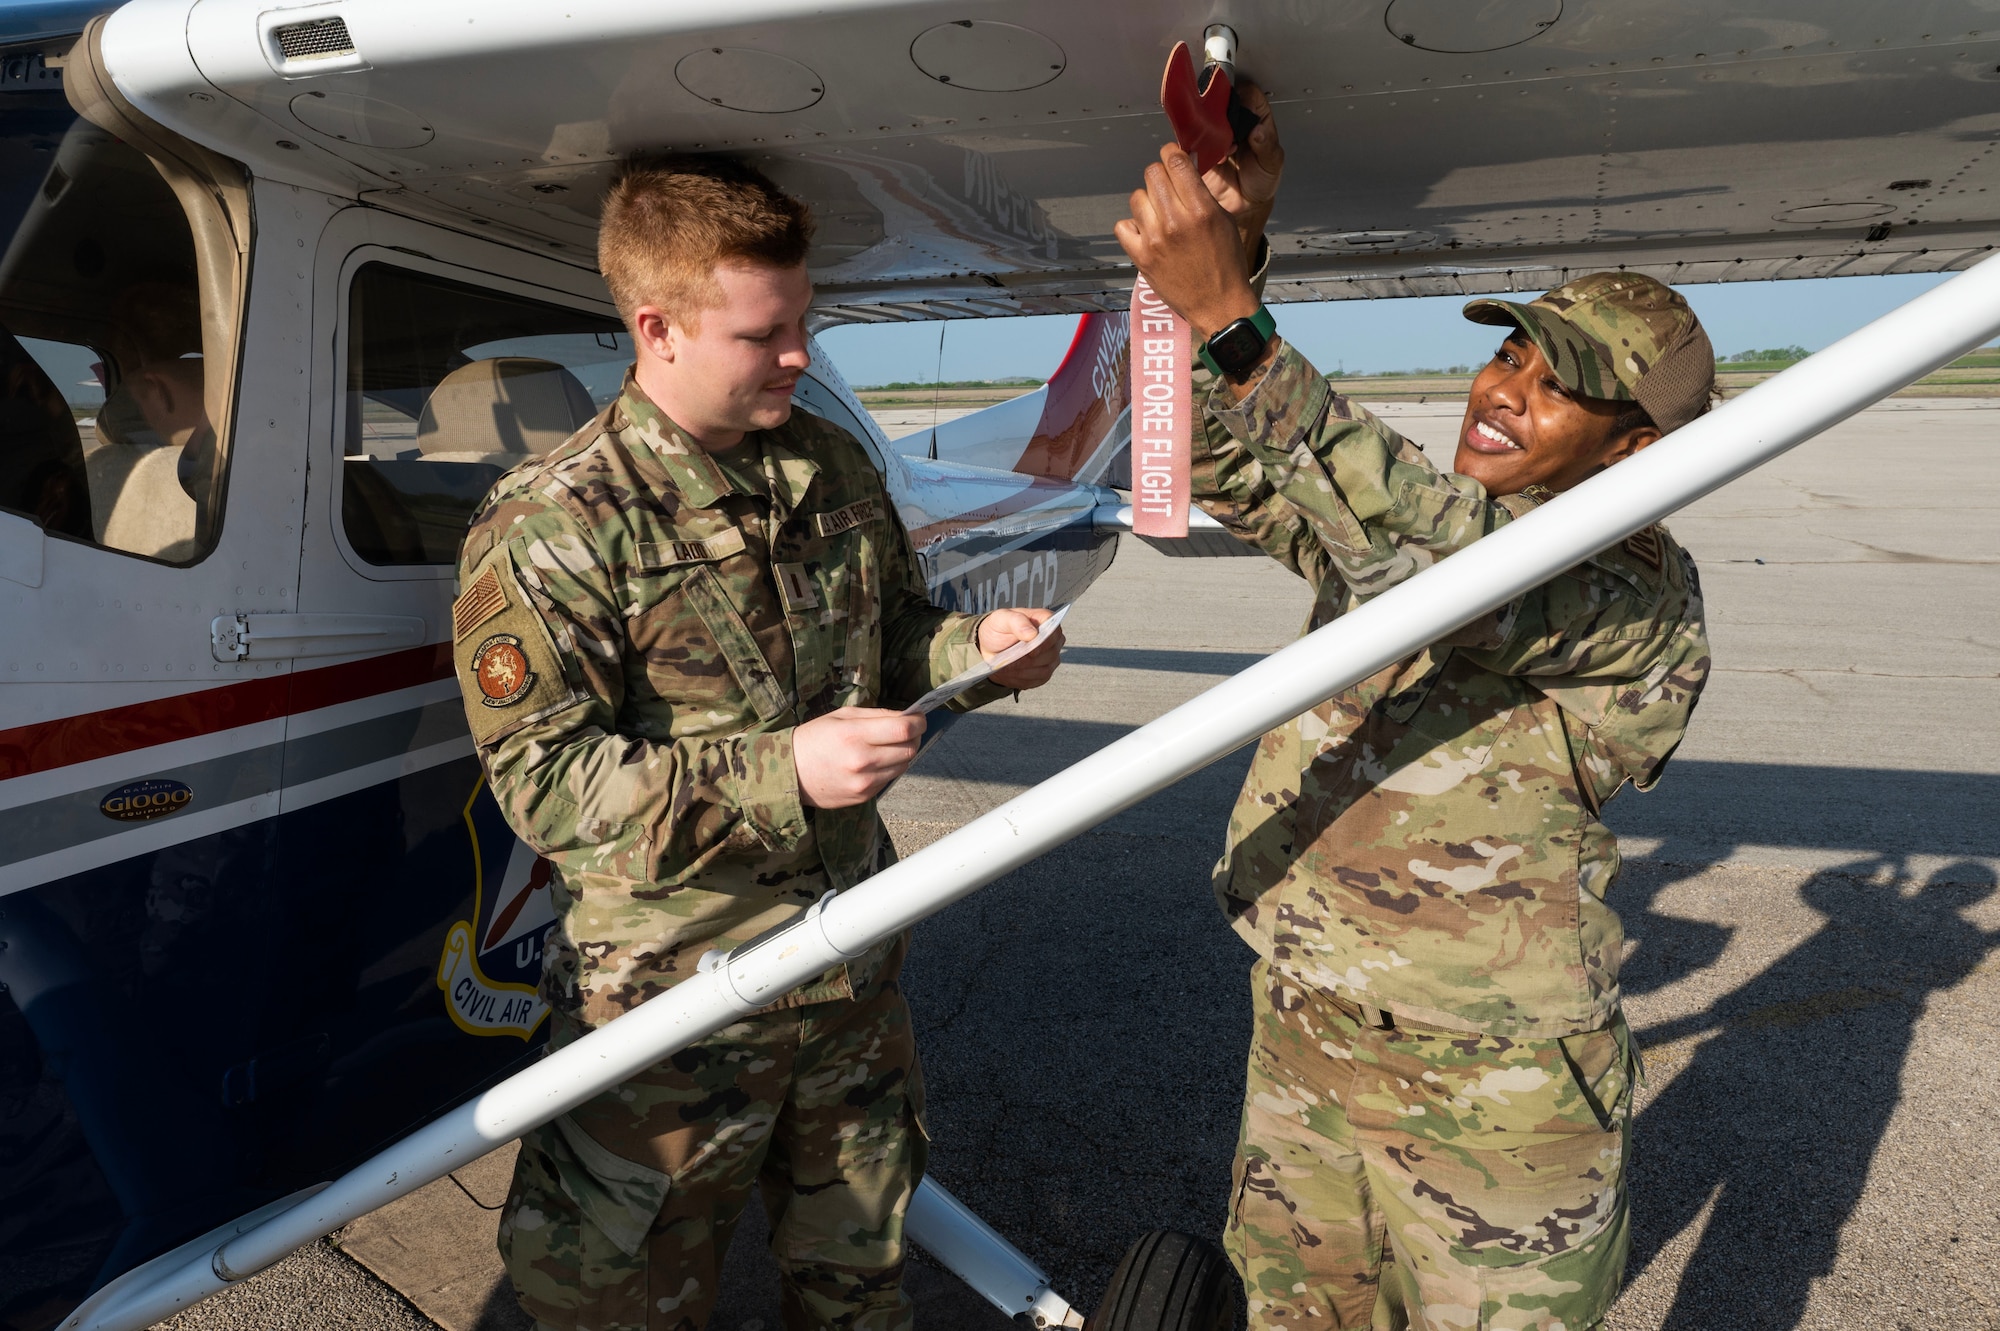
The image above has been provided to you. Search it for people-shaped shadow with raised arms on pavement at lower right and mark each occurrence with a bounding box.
[1626,855,2000,1331]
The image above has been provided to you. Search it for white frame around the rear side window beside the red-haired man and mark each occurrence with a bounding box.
[328,243,622,582]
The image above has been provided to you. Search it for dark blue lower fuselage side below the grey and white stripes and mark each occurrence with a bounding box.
[0,759,532,1311]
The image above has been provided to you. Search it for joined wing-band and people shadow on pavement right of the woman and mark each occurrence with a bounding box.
[1608,761,2000,1331]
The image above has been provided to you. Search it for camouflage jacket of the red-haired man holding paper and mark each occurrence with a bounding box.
[454,374,1000,1025]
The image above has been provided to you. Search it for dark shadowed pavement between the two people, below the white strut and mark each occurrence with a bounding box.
[906,815,1250,1311]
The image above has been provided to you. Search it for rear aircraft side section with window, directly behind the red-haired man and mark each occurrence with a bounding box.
[282,208,632,1161]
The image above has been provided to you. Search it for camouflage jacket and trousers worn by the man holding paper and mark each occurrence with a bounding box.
[454,160,1040,1331]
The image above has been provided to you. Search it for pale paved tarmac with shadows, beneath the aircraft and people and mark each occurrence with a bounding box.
[166,402,2000,1331]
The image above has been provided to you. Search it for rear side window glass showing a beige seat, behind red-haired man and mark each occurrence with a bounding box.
[340,264,632,564]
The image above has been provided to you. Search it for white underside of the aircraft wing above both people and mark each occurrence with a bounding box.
[106,0,2000,322]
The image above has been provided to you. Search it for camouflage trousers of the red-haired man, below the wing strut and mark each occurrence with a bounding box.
[500,979,924,1331]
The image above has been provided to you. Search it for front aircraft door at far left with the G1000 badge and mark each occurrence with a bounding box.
[0,48,340,1321]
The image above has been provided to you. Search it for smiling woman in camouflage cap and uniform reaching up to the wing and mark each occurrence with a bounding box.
[1120,100,1714,1331]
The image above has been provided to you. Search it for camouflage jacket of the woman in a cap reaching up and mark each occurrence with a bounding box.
[1194,346,1708,1037]
